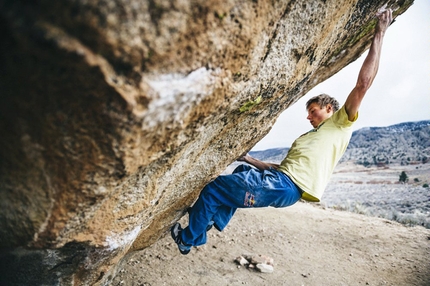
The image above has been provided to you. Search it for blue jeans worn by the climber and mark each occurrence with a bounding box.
[181,165,302,246]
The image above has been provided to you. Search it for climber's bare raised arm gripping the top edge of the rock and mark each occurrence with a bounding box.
[345,9,393,121]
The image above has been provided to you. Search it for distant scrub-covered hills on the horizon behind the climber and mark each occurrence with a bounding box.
[250,120,430,166]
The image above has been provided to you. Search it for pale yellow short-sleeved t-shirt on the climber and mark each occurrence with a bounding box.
[279,106,358,202]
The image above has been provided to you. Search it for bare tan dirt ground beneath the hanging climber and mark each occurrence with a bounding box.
[112,202,430,286]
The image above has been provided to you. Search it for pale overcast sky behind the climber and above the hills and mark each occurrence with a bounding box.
[253,0,430,151]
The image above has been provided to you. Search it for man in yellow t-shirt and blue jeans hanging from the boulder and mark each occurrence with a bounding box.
[171,10,392,254]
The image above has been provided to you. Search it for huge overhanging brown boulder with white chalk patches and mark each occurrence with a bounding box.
[0,0,412,285]
